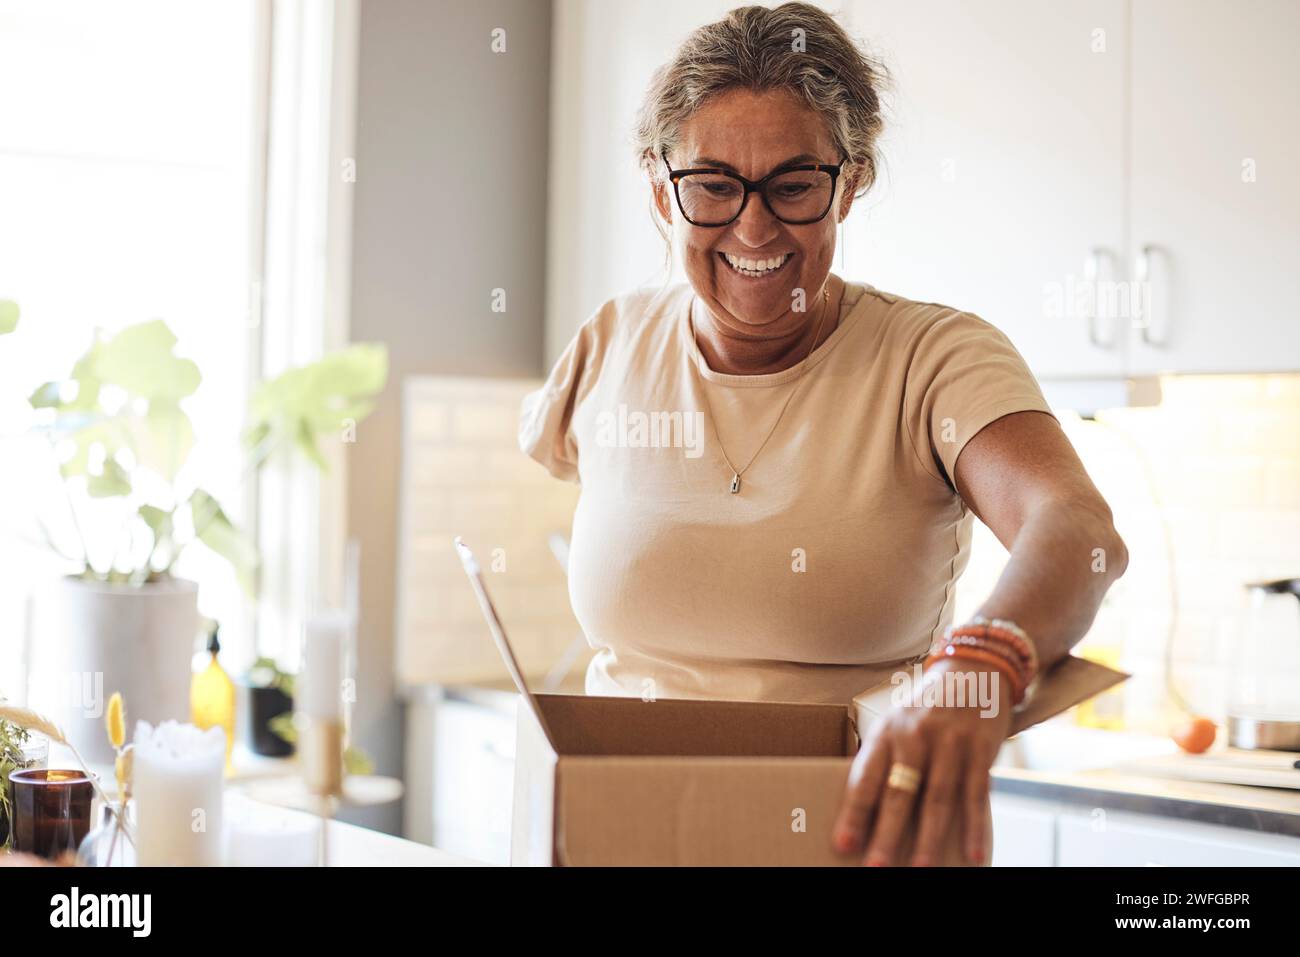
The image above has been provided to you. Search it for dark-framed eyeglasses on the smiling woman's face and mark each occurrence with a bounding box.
[663,153,844,226]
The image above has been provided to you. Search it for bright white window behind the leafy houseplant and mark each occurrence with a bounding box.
[0,0,265,681]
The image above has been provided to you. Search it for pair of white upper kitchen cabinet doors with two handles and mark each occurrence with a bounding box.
[842,0,1300,381]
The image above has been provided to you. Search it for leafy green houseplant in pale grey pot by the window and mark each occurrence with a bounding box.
[16,317,387,763]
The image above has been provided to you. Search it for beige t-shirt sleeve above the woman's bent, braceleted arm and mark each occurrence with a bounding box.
[904,312,1056,488]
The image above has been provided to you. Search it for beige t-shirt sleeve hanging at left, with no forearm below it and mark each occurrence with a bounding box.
[519,312,594,482]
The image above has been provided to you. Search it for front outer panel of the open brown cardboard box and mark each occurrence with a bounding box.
[555,757,858,867]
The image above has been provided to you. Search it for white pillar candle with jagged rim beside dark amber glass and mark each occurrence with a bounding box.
[131,722,226,867]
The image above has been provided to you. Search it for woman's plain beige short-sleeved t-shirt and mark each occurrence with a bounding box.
[520,276,1050,703]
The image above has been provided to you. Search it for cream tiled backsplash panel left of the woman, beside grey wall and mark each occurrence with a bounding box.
[395,376,581,685]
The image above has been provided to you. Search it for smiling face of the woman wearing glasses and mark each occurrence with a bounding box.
[655,90,853,339]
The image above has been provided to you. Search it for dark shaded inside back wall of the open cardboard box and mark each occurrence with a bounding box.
[536,694,853,757]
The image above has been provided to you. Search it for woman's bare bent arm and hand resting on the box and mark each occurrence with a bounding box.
[835,411,1128,865]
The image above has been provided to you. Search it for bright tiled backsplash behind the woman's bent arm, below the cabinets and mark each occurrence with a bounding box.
[957,374,1300,732]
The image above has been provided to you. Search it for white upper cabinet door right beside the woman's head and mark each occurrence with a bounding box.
[844,0,1127,378]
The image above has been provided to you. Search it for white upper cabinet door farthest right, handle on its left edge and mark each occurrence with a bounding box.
[1131,0,1300,373]
